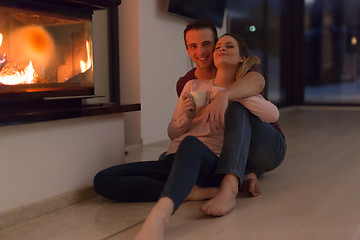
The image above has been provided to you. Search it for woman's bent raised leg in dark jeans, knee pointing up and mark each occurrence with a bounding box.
[161,136,219,212]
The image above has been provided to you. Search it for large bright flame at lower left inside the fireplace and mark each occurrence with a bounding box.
[0,61,38,85]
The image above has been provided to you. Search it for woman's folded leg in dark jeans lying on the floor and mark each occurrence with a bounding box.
[94,154,175,202]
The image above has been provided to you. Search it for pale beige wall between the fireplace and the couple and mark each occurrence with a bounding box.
[119,0,226,144]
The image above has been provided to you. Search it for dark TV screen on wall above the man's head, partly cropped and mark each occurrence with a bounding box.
[168,0,226,27]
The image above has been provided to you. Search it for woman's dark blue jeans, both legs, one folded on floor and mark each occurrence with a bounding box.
[94,136,219,211]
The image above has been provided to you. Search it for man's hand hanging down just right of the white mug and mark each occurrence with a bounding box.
[201,90,229,131]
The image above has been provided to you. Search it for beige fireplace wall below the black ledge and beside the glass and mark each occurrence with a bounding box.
[0,12,124,215]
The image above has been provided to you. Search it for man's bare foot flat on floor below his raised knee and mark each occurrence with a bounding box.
[200,174,239,216]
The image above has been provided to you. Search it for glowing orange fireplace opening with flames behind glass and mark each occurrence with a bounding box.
[0,6,94,102]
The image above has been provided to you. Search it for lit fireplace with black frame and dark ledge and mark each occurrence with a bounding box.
[0,0,140,124]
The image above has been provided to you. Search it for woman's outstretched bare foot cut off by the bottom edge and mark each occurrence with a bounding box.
[135,197,174,240]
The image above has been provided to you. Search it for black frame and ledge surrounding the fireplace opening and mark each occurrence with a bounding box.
[0,0,141,126]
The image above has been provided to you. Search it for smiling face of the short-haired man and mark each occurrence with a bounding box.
[186,28,215,69]
